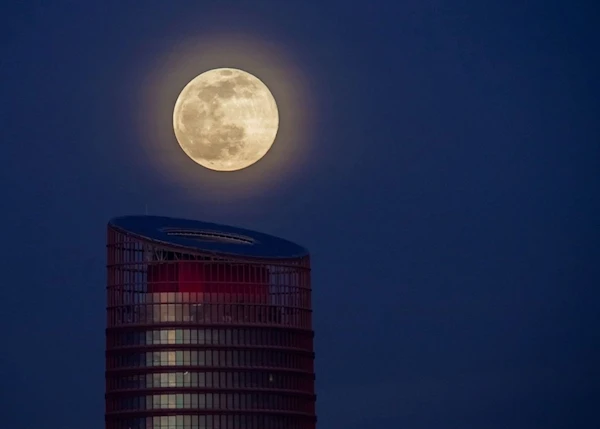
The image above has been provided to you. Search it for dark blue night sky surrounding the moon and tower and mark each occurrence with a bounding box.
[0,0,600,429]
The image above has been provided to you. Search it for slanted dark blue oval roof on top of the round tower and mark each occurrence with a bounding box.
[108,216,308,259]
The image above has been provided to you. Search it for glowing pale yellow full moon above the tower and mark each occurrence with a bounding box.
[173,68,279,171]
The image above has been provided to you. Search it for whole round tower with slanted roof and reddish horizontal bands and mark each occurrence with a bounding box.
[105,216,316,429]
